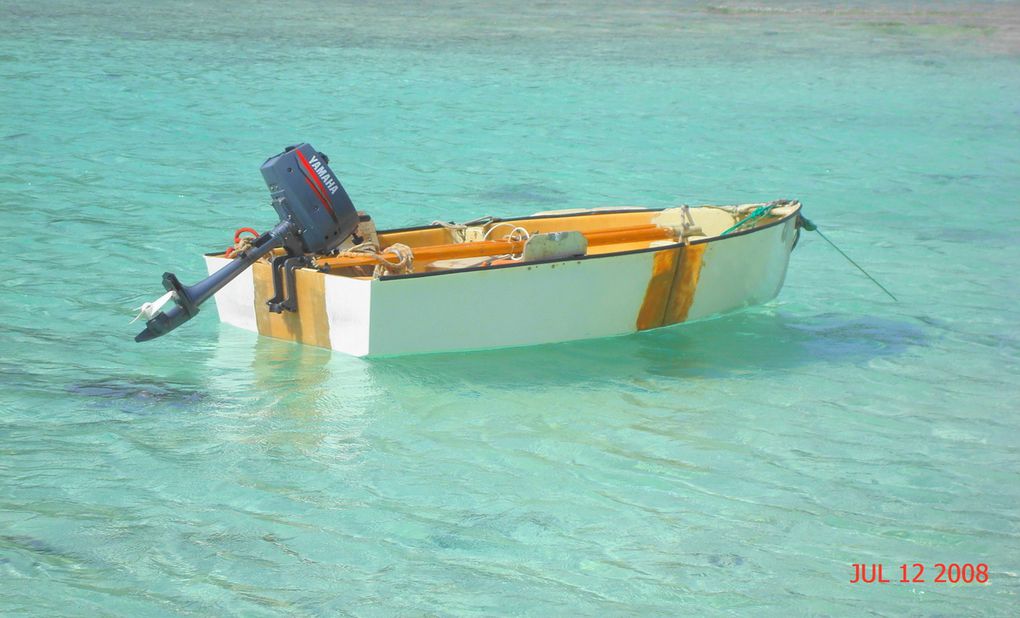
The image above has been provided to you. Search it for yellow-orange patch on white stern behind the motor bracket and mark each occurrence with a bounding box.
[252,261,329,348]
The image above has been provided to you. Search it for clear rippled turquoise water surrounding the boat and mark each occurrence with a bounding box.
[0,0,1020,616]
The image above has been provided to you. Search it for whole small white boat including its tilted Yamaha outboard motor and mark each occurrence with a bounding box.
[136,145,805,356]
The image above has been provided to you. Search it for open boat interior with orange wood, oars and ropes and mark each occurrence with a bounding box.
[219,200,800,278]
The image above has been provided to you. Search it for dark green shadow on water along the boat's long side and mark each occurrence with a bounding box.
[367,308,927,390]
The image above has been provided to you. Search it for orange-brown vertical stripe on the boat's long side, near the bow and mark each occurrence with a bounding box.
[636,244,708,330]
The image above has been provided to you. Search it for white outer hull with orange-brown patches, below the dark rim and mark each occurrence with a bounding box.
[206,206,798,356]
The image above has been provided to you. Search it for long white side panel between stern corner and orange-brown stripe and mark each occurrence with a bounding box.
[370,252,654,355]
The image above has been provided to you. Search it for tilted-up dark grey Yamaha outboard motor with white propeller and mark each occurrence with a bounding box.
[135,144,358,342]
